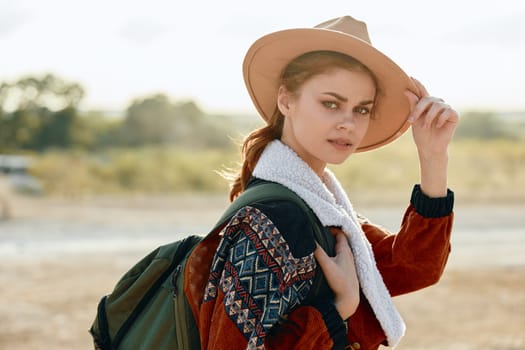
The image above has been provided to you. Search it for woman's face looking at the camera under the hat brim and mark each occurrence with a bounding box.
[277,68,376,174]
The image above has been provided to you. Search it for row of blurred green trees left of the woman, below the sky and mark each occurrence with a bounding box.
[0,74,238,151]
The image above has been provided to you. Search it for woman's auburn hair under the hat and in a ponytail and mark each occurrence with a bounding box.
[230,51,378,201]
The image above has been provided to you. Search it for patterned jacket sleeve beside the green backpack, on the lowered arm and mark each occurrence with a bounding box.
[199,204,346,349]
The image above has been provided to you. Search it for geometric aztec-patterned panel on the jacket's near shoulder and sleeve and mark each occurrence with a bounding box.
[203,206,316,349]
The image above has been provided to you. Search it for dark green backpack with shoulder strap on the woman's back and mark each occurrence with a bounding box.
[90,181,334,350]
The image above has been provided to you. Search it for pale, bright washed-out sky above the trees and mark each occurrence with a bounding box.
[0,0,525,113]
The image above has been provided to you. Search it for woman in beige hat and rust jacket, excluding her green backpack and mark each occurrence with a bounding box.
[185,17,458,349]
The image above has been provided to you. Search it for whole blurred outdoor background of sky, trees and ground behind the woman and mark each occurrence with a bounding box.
[0,0,525,349]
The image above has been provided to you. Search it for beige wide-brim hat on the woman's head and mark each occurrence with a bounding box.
[243,16,417,152]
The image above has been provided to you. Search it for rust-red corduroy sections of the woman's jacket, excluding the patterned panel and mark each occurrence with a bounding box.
[184,186,453,350]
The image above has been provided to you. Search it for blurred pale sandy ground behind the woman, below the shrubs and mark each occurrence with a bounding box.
[0,197,525,350]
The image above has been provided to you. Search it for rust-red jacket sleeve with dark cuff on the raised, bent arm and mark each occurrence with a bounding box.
[362,185,454,296]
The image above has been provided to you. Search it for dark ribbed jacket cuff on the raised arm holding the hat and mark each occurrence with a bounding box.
[410,185,454,218]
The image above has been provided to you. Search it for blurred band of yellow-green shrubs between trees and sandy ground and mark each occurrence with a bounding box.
[26,137,525,202]
